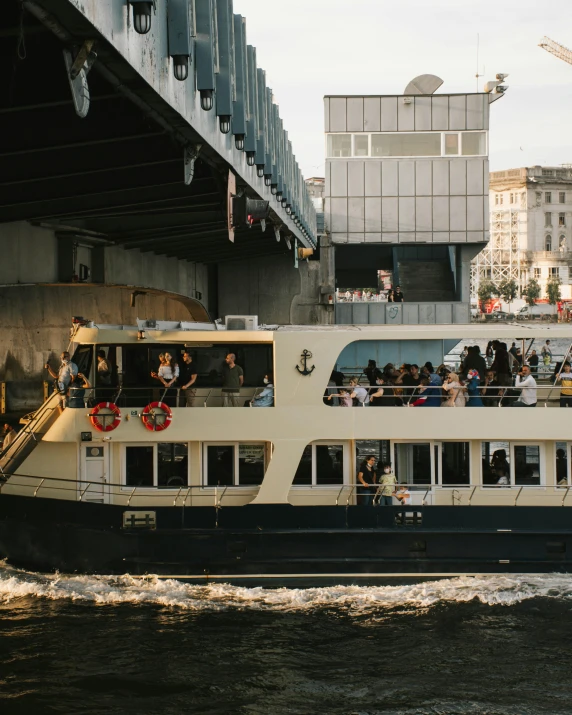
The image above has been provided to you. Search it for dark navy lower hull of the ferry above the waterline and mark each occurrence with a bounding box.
[0,494,572,586]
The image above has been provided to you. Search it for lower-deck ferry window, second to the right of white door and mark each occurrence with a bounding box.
[204,442,268,487]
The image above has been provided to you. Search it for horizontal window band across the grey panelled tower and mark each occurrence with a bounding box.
[327,132,487,159]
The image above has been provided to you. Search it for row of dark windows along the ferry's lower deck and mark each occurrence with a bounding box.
[119,440,572,489]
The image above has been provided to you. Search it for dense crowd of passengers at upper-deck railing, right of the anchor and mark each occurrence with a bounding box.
[324,340,572,407]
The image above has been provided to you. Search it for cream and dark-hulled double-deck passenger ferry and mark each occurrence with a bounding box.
[0,321,572,585]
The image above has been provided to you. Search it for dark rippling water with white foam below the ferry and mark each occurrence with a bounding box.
[0,565,572,715]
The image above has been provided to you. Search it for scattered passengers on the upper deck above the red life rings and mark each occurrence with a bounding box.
[44,350,274,408]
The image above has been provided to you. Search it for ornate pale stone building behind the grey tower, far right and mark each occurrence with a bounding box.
[471,165,572,301]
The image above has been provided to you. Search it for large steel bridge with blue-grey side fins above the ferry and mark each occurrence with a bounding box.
[0,0,326,412]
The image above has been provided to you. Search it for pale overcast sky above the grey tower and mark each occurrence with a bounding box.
[234,0,572,178]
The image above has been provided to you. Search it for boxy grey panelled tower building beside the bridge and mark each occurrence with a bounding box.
[321,75,504,324]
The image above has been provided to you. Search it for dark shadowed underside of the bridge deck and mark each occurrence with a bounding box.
[0,0,288,264]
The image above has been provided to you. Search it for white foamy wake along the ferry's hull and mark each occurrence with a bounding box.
[0,565,572,615]
